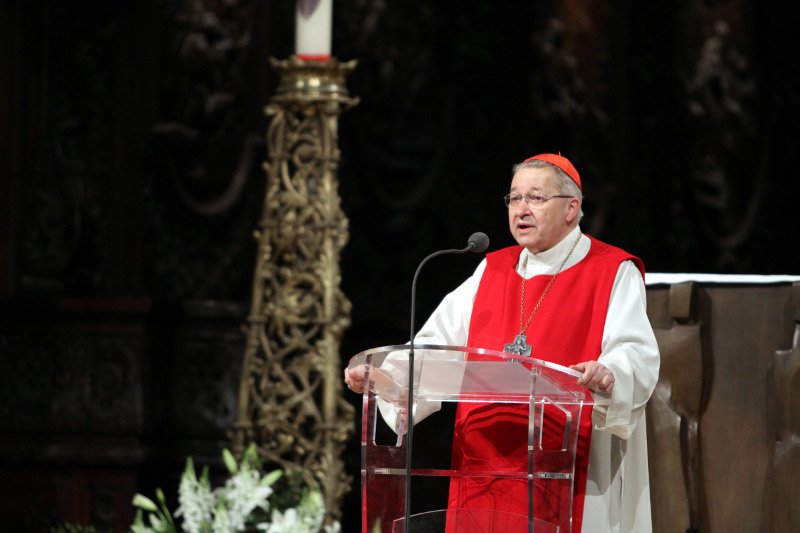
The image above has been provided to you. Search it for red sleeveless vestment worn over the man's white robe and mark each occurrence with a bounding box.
[447,238,644,533]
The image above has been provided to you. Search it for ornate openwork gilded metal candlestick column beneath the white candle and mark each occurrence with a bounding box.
[233,56,358,520]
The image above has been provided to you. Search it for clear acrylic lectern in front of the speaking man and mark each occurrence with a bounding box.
[348,345,592,533]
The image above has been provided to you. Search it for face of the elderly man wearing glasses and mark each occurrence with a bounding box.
[508,168,579,253]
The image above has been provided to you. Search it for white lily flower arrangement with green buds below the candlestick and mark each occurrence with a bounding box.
[131,444,340,533]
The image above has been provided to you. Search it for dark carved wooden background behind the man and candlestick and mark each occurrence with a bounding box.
[0,0,800,530]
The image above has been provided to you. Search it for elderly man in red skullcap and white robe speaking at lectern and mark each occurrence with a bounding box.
[345,154,659,532]
